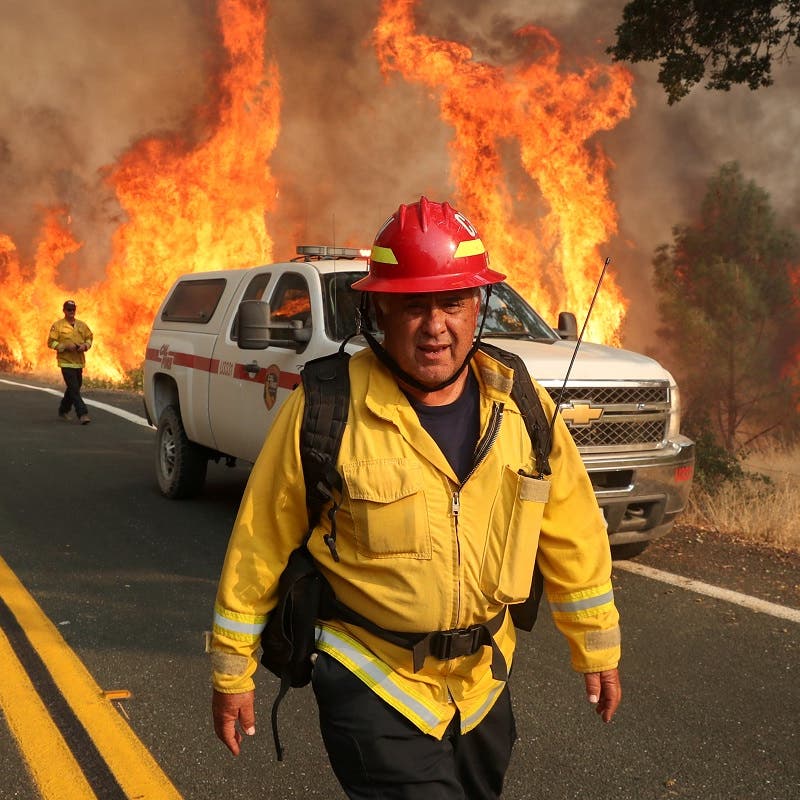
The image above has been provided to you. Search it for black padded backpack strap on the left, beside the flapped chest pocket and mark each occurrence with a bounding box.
[300,350,350,561]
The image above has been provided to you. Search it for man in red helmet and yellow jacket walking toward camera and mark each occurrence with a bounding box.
[211,197,621,800]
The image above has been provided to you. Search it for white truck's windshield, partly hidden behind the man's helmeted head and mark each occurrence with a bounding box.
[322,272,559,341]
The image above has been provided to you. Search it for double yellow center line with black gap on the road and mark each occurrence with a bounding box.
[0,558,181,800]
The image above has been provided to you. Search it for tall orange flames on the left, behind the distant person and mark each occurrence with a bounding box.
[0,0,280,381]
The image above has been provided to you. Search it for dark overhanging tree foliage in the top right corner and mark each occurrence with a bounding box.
[607,0,800,104]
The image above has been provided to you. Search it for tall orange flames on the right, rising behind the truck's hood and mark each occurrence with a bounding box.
[374,0,633,344]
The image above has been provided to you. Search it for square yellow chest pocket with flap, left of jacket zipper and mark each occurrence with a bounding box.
[342,458,431,559]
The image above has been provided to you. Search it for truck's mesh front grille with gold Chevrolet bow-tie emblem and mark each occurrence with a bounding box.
[548,382,670,452]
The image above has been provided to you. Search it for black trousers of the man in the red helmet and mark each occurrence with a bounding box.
[312,653,517,800]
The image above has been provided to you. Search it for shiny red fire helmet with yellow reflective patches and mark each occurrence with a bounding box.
[353,197,505,293]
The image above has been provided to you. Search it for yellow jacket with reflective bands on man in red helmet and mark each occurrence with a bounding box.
[211,350,620,738]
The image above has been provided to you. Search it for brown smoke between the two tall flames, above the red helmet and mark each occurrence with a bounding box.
[268,0,452,257]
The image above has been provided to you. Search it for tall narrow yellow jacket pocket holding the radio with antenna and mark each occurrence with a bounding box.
[481,467,550,603]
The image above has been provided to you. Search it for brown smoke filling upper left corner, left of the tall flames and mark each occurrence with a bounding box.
[0,0,212,274]
